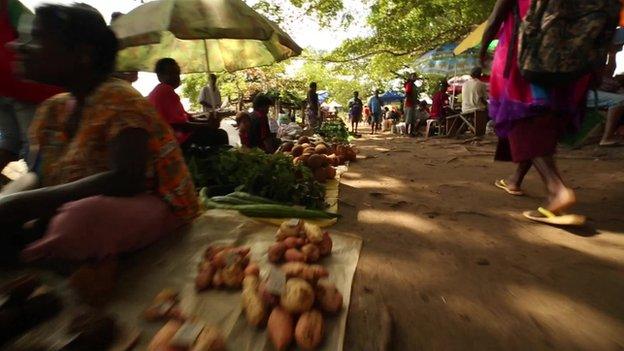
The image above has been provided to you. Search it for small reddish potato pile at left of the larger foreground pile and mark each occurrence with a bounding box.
[195,246,259,292]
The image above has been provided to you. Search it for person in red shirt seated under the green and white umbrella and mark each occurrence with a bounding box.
[147,58,229,151]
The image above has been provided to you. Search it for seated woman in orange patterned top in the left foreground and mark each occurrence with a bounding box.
[0,5,198,260]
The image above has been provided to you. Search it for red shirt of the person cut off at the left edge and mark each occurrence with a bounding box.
[0,11,63,104]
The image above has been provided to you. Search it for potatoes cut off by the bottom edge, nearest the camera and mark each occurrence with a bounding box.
[147,320,225,351]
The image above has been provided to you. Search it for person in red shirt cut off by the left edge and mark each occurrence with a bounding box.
[0,0,63,185]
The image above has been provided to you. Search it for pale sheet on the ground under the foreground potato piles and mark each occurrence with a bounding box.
[110,210,362,351]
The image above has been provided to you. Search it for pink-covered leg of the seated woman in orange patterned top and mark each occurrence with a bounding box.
[22,194,179,261]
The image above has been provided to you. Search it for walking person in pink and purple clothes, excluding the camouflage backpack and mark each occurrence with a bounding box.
[481,0,619,224]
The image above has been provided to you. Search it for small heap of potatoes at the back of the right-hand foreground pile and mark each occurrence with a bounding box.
[269,219,333,263]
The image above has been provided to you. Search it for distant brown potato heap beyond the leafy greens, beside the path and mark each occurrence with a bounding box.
[280,136,356,183]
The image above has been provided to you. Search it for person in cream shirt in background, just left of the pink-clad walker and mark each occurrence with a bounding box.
[462,67,488,135]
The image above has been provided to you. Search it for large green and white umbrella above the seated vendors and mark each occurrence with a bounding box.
[111,0,302,73]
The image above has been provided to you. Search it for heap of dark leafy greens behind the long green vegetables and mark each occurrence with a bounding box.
[187,149,327,209]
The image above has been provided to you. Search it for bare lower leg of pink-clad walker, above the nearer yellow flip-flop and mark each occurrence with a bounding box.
[533,155,576,213]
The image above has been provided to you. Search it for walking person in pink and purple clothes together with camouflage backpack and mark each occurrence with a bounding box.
[480,0,621,225]
